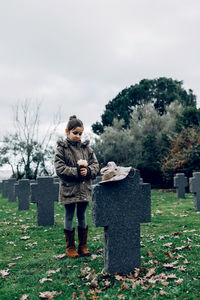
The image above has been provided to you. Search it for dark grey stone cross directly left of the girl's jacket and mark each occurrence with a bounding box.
[31,176,59,226]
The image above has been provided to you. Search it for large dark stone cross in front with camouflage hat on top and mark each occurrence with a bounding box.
[92,169,151,274]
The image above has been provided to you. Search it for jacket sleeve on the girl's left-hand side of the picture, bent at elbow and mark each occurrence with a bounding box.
[54,146,79,180]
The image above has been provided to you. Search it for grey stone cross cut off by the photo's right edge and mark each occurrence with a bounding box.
[189,172,200,211]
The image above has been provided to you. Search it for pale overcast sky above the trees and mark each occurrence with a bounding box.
[0,0,200,141]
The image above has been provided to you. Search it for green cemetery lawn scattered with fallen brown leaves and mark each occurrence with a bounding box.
[0,190,200,300]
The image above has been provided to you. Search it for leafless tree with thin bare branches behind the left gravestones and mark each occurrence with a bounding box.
[0,99,60,179]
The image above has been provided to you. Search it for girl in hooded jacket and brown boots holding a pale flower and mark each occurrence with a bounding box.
[54,116,99,258]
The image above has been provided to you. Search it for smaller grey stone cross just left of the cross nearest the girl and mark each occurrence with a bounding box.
[14,179,30,210]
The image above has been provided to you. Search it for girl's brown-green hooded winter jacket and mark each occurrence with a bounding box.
[54,139,99,204]
